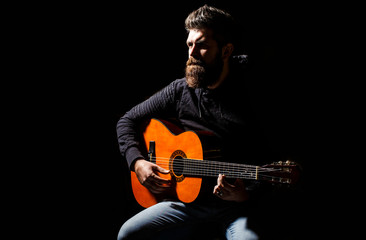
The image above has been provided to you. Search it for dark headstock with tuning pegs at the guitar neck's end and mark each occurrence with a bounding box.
[258,160,301,186]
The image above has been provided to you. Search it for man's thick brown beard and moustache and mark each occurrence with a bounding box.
[186,55,224,88]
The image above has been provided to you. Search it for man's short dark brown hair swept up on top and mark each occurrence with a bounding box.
[185,4,236,47]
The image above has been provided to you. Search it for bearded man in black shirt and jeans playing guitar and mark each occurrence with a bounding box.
[117,5,273,240]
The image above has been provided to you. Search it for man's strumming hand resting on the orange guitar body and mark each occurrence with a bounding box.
[134,159,171,194]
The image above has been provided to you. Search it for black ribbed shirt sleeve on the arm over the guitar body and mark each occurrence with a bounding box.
[116,81,181,171]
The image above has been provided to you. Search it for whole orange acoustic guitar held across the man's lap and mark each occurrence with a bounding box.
[131,119,299,208]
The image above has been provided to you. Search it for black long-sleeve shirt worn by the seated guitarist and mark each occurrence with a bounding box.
[117,55,273,204]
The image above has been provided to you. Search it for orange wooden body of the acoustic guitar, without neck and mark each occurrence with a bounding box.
[131,119,203,208]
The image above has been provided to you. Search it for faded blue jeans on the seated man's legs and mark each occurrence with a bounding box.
[118,201,258,240]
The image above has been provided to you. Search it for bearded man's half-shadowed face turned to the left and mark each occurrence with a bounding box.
[186,29,223,88]
